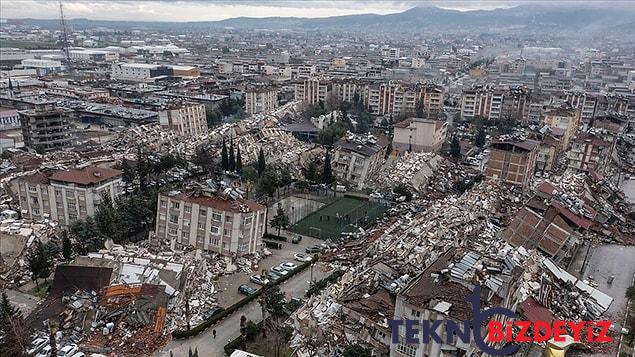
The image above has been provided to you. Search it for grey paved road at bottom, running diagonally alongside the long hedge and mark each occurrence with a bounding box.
[155,263,329,357]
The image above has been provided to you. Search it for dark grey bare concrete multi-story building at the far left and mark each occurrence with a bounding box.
[19,104,73,151]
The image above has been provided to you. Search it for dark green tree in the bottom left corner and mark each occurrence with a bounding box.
[0,291,31,356]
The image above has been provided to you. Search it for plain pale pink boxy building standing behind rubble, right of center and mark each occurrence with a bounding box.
[392,118,448,152]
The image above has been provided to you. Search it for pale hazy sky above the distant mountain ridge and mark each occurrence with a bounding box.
[0,0,628,21]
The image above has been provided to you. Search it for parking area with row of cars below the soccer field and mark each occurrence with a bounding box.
[218,232,322,307]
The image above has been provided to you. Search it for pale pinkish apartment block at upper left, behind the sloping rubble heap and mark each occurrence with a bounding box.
[159,103,207,137]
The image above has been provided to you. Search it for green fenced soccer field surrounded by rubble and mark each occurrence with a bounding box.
[289,197,387,239]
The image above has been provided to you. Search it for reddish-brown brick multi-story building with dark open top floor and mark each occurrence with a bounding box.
[485,140,539,189]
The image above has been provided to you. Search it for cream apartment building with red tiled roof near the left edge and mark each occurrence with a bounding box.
[11,166,123,226]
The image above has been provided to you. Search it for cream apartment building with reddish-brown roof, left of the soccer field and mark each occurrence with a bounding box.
[156,192,267,256]
